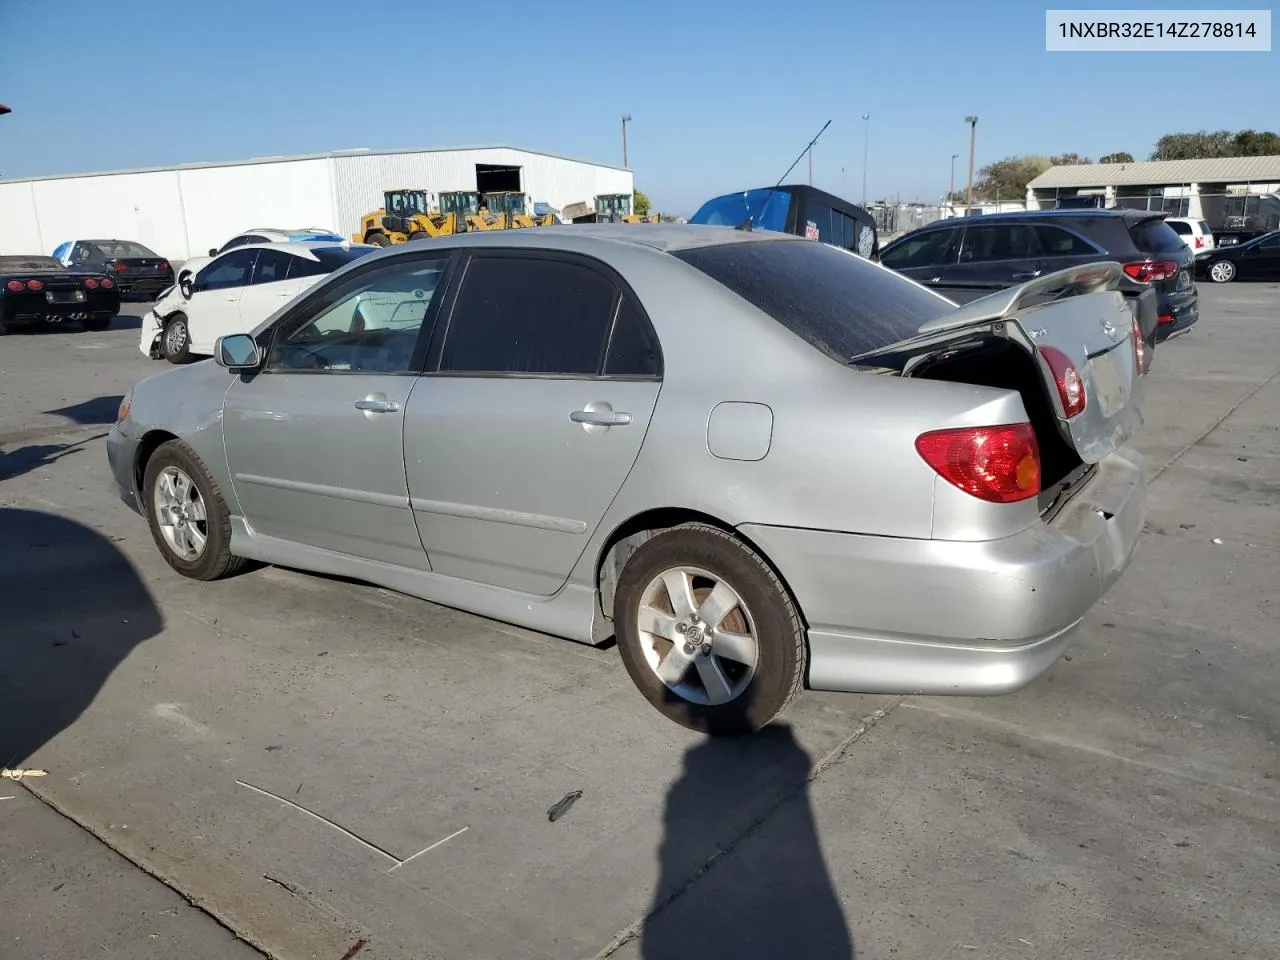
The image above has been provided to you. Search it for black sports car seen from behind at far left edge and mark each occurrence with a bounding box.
[0,256,120,333]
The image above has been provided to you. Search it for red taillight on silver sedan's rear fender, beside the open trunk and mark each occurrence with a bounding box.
[915,424,1041,503]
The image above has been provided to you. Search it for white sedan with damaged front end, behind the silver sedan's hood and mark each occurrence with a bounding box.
[138,241,378,364]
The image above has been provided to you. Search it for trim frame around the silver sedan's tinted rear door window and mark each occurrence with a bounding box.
[422,246,667,383]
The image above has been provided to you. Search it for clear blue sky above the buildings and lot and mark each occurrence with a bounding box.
[0,0,1280,212]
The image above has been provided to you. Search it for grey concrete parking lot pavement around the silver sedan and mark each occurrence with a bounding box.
[0,283,1280,960]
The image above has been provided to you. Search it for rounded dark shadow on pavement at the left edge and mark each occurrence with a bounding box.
[0,507,164,768]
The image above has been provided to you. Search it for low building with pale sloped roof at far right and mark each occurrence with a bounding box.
[1027,156,1280,232]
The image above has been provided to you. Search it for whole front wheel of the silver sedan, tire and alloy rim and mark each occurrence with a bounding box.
[142,440,247,580]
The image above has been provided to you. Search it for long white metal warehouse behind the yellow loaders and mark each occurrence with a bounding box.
[0,146,634,260]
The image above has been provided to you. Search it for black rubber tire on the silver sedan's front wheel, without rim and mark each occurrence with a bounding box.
[142,440,248,580]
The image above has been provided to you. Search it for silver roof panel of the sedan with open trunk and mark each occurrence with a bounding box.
[385,223,813,253]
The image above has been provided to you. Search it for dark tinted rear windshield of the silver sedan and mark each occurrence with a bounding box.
[675,241,955,362]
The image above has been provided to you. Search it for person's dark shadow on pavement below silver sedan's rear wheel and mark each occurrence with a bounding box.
[640,723,854,960]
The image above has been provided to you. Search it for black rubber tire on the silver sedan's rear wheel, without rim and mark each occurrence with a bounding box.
[613,524,808,736]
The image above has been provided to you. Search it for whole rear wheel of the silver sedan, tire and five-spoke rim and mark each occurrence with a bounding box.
[613,524,806,736]
